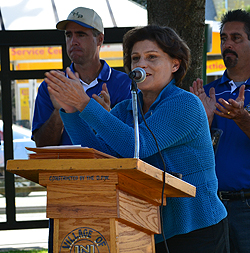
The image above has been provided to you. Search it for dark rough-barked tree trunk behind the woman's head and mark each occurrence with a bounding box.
[147,0,205,90]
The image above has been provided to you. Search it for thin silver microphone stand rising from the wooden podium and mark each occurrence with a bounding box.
[131,78,140,158]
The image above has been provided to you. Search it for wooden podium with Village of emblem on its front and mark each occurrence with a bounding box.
[7,158,196,253]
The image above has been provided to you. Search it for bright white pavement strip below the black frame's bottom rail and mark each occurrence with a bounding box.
[0,228,49,252]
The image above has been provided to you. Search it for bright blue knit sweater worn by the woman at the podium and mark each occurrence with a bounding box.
[60,80,227,242]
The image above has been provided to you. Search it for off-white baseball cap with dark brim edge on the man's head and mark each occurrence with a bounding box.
[56,7,104,34]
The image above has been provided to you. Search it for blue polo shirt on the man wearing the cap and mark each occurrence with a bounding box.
[32,60,131,145]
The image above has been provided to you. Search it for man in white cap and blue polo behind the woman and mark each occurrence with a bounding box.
[32,7,131,147]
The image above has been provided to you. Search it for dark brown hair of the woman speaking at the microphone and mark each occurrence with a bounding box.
[123,25,190,86]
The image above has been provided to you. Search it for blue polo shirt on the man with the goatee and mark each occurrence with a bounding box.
[204,71,250,191]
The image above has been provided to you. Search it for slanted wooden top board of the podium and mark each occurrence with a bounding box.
[7,158,196,197]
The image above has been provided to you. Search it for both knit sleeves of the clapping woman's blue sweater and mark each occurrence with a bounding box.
[61,93,205,159]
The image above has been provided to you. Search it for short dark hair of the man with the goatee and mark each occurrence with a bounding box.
[220,9,250,40]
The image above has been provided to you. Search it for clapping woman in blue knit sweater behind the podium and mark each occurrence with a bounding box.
[46,25,227,253]
